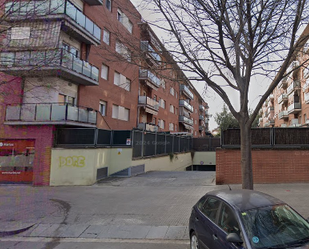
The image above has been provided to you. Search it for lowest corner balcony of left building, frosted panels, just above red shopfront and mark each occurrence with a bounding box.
[4,103,97,127]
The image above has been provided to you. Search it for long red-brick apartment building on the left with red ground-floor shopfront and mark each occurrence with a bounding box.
[0,0,208,185]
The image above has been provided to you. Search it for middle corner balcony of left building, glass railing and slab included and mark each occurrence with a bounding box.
[0,49,99,86]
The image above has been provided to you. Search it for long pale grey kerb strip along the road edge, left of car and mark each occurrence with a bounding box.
[0,237,189,245]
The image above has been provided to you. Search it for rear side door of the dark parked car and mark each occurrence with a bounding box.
[195,197,221,249]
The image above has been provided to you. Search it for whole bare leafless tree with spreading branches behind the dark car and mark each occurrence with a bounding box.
[142,0,309,189]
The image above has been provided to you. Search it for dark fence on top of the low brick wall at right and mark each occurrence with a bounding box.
[221,127,309,148]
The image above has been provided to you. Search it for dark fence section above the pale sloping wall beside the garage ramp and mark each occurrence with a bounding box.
[133,130,193,158]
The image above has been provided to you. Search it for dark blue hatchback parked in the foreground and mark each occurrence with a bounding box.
[189,190,309,249]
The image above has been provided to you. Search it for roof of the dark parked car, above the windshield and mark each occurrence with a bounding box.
[206,189,285,211]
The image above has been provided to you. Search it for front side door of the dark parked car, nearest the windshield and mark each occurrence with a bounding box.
[211,202,244,249]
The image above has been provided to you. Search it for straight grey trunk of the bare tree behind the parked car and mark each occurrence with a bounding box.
[240,122,253,189]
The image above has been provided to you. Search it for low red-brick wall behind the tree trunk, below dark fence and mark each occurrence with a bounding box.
[216,149,309,184]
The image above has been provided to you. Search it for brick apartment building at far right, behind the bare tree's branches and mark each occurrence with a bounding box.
[259,43,309,127]
